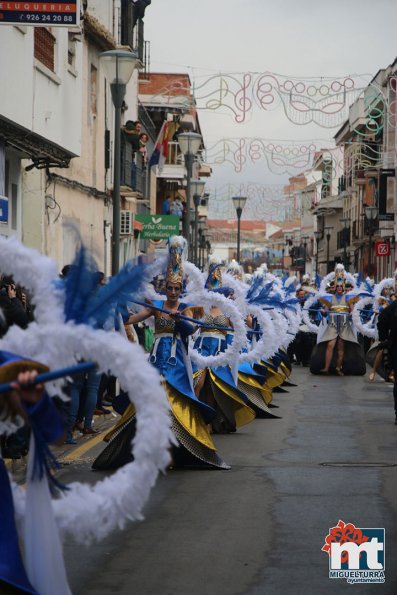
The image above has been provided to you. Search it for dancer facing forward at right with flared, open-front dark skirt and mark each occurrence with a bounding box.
[310,264,365,376]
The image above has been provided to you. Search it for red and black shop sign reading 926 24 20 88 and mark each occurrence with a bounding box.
[0,0,80,27]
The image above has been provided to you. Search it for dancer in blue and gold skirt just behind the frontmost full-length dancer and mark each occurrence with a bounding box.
[194,259,255,434]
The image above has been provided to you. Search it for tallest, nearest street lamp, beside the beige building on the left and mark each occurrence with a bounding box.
[99,50,139,275]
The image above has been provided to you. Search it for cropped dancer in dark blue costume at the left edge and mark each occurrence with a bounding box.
[0,351,70,595]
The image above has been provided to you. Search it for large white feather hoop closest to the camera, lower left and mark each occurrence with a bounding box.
[2,324,174,543]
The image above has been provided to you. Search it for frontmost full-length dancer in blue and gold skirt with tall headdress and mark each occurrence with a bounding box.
[93,236,230,470]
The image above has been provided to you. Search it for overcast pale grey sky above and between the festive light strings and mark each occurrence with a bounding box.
[145,0,397,206]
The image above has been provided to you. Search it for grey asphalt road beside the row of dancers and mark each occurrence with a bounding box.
[61,368,397,595]
